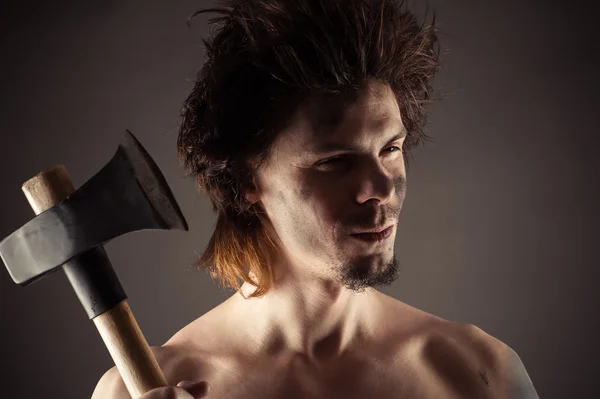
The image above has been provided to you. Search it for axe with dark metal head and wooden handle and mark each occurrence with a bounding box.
[0,130,188,398]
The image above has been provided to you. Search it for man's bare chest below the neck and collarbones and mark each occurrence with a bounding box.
[163,298,500,399]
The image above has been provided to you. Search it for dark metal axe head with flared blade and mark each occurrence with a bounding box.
[0,130,188,285]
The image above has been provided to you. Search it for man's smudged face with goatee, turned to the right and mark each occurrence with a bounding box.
[248,83,406,290]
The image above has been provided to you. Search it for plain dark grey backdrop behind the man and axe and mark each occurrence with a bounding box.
[0,0,600,399]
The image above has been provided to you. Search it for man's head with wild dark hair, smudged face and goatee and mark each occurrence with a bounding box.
[178,0,438,295]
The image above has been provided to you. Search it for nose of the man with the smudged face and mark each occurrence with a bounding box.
[356,161,396,204]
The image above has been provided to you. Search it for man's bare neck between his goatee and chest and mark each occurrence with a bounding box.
[231,270,376,363]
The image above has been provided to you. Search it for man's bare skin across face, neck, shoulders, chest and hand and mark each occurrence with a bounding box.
[92,82,537,399]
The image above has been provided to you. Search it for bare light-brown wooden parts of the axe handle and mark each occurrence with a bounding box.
[22,165,167,398]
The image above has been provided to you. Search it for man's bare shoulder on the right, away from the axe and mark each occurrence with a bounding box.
[376,297,538,399]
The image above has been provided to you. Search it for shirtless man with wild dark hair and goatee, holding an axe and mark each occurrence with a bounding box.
[92,0,537,399]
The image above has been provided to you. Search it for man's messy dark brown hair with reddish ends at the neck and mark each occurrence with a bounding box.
[177,0,439,296]
